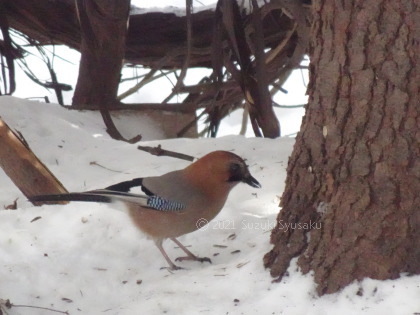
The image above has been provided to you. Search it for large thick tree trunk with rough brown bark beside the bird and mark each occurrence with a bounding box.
[264,0,420,294]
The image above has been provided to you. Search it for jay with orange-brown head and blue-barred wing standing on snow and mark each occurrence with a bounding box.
[28,151,261,270]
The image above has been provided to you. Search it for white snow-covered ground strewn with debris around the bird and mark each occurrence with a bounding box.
[0,97,420,315]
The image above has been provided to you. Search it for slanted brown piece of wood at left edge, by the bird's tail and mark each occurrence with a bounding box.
[0,119,67,202]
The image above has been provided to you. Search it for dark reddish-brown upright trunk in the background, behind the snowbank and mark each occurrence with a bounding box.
[73,0,130,108]
